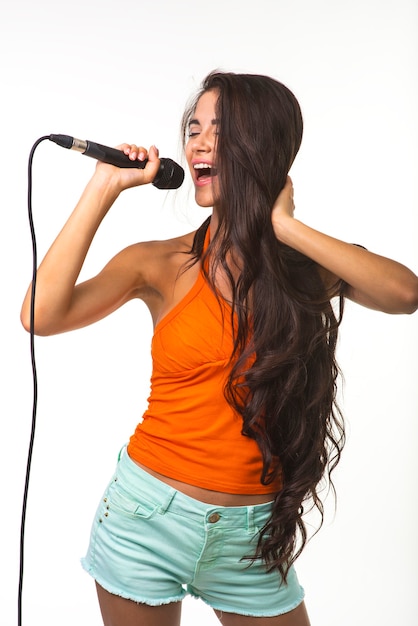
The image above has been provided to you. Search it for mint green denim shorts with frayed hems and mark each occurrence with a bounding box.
[82,450,304,617]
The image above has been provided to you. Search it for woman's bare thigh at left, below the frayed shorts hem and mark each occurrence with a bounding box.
[96,583,181,626]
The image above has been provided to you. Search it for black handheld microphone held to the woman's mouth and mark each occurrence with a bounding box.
[48,135,184,189]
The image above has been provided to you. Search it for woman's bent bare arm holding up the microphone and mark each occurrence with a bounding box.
[21,144,159,335]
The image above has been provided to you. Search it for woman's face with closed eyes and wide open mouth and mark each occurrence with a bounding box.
[186,91,218,207]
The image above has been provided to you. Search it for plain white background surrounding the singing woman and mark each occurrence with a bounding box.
[0,0,418,626]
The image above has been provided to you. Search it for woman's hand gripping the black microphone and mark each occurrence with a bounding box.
[95,143,160,193]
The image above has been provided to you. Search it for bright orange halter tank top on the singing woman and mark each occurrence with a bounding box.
[128,228,281,494]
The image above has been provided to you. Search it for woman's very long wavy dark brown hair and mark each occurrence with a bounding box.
[183,72,345,580]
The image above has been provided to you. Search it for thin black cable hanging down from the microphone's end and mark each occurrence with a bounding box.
[17,135,49,626]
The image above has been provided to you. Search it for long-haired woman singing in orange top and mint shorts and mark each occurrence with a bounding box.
[22,73,418,626]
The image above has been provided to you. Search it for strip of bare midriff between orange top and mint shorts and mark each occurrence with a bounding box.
[132,459,275,506]
